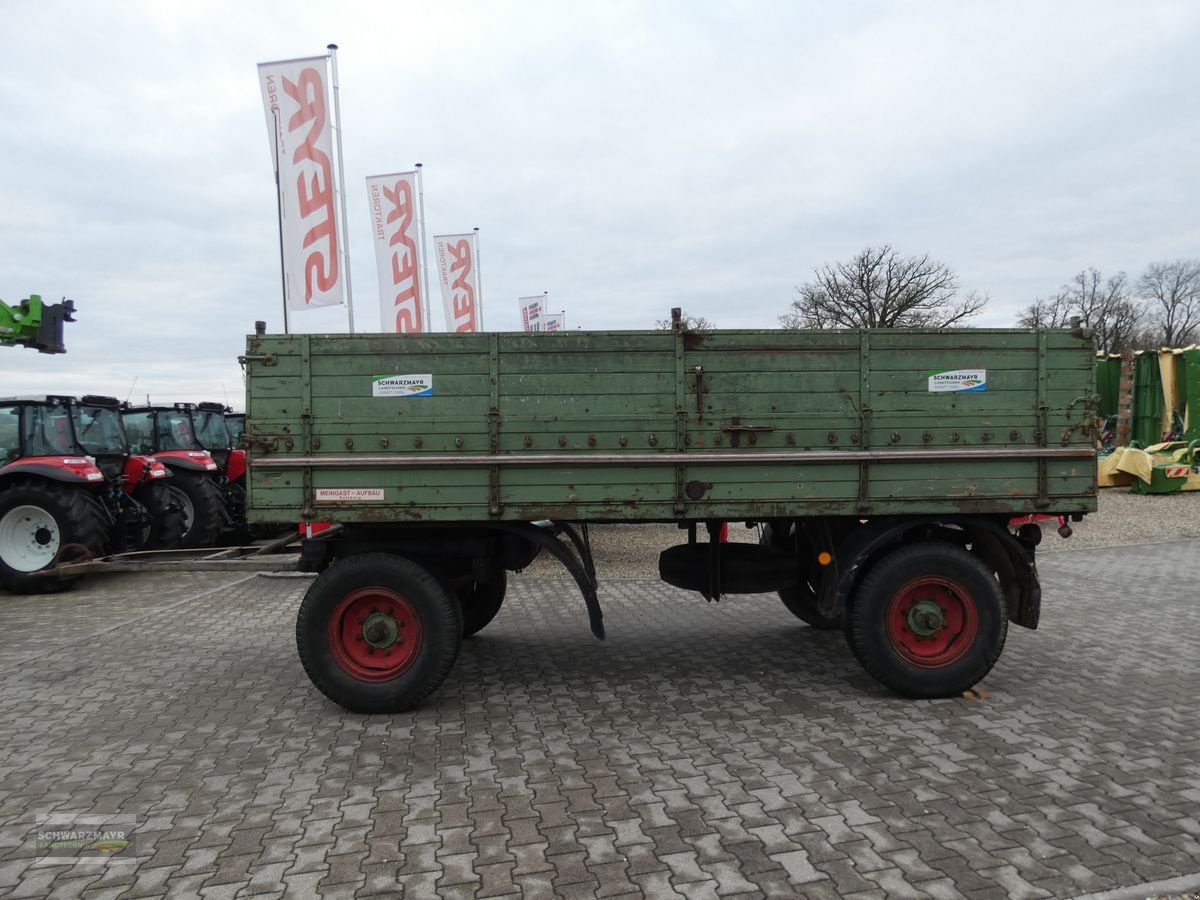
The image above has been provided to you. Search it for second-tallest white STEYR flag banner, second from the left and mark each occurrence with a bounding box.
[367,172,428,335]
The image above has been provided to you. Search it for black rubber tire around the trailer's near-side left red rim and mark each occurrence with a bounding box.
[296,553,462,714]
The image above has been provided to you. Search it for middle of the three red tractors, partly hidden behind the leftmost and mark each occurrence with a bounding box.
[121,404,229,547]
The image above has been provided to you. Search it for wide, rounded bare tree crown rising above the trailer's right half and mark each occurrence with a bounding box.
[779,244,988,328]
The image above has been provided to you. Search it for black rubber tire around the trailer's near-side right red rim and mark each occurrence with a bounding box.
[846,541,1008,698]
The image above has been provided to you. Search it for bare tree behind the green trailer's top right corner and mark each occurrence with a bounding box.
[1016,269,1145,353]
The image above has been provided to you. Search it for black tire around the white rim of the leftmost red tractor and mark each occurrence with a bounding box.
[0,480,108,594]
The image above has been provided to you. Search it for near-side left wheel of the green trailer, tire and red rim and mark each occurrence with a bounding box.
[296,553,462,713]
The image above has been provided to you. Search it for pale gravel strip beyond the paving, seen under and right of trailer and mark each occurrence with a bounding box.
[522,488,1200,578]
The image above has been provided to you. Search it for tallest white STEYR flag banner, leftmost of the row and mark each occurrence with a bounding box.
[258,56,342,310]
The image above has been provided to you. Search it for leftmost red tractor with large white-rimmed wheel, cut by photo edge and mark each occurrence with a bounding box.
[0,396,182,593]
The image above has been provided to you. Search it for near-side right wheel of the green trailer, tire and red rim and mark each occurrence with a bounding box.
[846,542,1008,697]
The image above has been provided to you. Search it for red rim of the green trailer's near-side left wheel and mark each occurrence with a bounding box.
[329,587,421,682]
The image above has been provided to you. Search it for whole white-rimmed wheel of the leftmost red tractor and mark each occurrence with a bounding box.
[0,481,108,594]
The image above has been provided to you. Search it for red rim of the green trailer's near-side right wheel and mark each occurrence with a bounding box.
[887,575,979,668]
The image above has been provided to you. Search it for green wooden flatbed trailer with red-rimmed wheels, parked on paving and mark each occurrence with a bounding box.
[244,316,1098,712]
